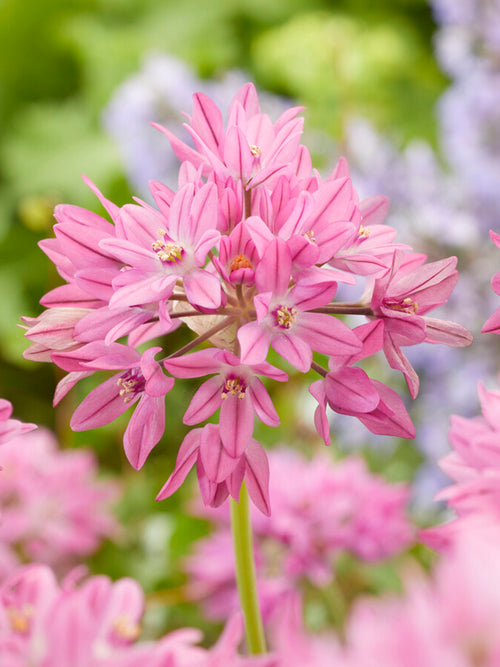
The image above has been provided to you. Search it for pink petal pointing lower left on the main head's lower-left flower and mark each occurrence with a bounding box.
[70,374,134,431]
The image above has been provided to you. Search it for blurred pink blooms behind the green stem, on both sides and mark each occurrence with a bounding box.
[186,449,414,618]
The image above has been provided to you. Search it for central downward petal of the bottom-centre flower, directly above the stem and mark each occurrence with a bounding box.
[219,395,254,458]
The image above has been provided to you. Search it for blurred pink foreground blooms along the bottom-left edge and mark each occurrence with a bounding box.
[0,565,277,667]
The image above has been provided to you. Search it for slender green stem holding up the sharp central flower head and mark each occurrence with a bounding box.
[231,482,267,655]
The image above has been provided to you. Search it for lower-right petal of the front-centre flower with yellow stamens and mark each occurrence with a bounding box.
[295,313,362,355]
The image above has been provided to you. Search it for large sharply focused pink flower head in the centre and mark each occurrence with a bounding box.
[24,84,471,514]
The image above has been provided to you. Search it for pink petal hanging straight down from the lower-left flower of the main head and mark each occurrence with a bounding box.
[123,394,165,470]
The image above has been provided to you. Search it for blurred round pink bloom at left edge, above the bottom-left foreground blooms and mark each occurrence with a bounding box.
[0,429,118,580]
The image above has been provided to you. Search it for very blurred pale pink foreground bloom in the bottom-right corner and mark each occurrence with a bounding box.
[338,527,500,667]
